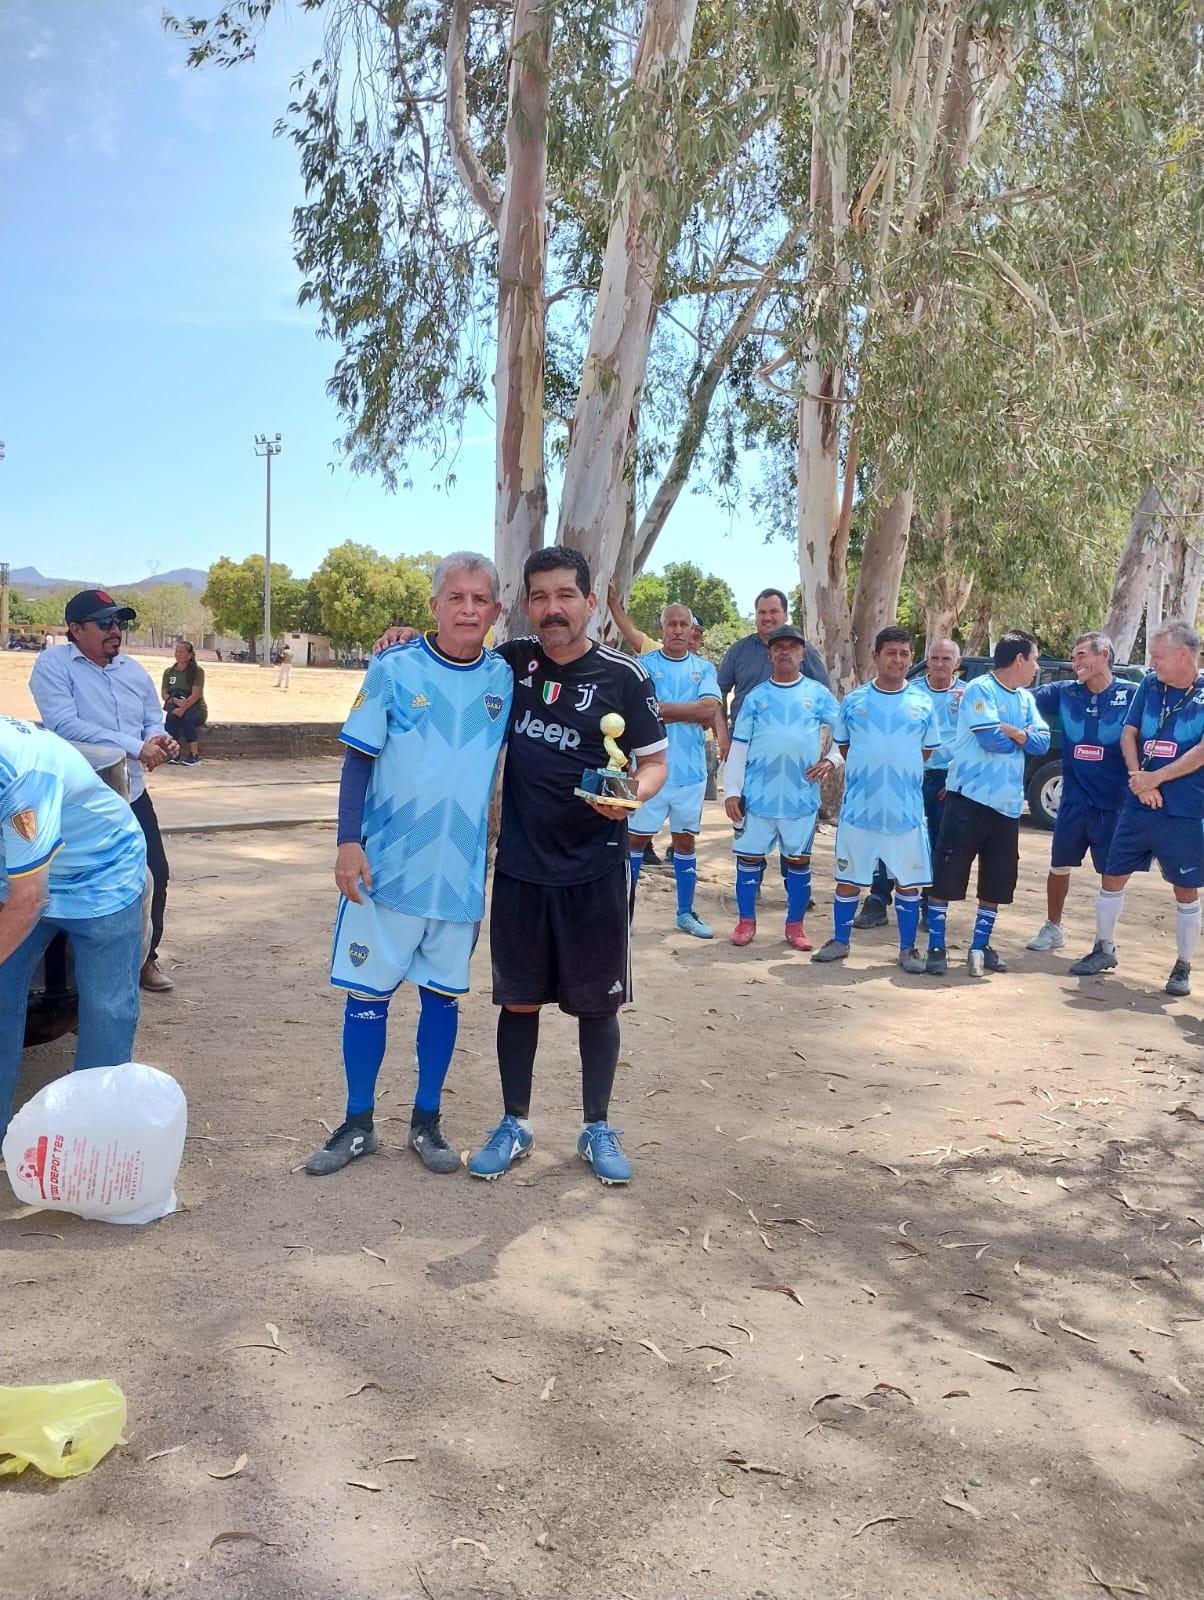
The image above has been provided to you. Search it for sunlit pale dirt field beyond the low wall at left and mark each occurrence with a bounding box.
[0,650,363,722]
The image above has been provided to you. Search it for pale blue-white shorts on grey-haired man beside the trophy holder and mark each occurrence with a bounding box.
[330,899,480,1000]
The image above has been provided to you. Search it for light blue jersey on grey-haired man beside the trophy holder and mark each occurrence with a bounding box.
[339,637,514,922]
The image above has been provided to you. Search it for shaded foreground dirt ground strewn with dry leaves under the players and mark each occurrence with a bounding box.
[0,806,1204,1600]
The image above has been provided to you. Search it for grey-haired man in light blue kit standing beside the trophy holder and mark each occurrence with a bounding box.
[306,550,514,1176]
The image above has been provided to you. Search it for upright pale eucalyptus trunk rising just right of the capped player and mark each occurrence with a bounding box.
[797,0,853,686]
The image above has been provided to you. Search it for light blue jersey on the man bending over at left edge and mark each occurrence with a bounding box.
[0,717,146,920]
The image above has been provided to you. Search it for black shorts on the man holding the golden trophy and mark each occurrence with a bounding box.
[490,854,631,1016]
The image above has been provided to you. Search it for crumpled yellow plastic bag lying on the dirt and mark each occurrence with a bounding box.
[0,1378,126,1478]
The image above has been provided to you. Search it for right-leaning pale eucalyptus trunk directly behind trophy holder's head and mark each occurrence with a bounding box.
[557,0,698,611]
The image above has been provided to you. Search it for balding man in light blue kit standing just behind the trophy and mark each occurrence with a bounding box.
[628,605,719,939]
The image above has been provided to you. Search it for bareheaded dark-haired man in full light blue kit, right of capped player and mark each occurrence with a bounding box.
[812,627,940,973]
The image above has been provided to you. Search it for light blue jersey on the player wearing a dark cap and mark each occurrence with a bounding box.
[732,678,841,818]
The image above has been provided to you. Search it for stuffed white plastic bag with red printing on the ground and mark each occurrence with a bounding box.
[3,1061,187,1222]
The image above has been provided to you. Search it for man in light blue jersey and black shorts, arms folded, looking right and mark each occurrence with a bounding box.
[927,630,1049,978]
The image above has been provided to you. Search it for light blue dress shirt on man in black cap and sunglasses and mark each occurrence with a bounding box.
[29,645,165,800]
